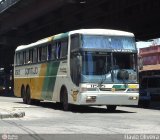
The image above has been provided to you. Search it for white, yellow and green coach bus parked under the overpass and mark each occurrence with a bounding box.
[14,29,139,110]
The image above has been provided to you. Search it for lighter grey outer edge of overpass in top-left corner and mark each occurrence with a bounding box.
[0,0,20,13]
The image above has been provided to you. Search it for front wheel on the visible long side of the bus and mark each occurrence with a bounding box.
[61,87,70,111]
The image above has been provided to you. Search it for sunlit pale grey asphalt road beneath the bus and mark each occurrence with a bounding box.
[0,96,160,139]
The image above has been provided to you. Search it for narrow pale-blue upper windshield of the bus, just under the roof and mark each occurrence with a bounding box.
[82,35,136,51]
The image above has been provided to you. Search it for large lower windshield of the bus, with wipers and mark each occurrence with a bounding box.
[81,52,137,83]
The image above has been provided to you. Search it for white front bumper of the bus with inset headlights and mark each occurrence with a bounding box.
[78,92,139,105]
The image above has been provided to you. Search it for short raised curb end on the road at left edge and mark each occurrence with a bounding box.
[0,111,25,119]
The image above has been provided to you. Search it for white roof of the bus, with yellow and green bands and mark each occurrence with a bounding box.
[15,29,134,51]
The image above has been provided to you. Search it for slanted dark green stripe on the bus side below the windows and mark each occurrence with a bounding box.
[42,61,60,100]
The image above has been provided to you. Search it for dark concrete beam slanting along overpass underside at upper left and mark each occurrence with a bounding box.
[0,0,65,35]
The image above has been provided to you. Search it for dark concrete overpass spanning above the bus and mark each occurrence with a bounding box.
[0,0,160,69]
